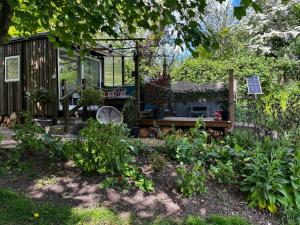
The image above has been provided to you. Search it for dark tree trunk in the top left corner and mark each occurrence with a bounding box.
[0,0,13,45]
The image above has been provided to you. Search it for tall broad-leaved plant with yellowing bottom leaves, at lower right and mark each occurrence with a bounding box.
[241,138,291,213]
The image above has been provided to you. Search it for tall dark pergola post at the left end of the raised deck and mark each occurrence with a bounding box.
[134,41,141,119]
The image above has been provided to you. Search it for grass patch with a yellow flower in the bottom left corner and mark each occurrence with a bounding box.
[0,190,129,225]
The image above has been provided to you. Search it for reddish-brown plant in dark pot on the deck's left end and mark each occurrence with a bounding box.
[144,75,170,119]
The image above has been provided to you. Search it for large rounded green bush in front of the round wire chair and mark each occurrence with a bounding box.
[73,119,132,175]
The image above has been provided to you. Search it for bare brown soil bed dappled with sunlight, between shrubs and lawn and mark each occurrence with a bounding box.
[0,134,281,225]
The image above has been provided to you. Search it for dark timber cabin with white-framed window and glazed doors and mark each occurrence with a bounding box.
[0,33,124,120]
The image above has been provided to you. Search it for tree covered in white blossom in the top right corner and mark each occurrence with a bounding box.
[242,0,300,57]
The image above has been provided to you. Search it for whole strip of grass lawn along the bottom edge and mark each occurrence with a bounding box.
[0,190,249,225]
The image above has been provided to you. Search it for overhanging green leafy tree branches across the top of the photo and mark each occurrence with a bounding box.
[0,0,258,49]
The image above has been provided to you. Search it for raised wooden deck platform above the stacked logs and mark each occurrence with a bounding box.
[139,117,231,130]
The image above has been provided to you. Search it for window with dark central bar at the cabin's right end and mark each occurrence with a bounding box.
[104,57,122,87]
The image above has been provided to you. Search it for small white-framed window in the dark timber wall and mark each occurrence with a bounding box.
[5,55,20,82]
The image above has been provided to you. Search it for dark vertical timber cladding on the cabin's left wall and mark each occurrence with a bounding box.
[0,35,57,115]
